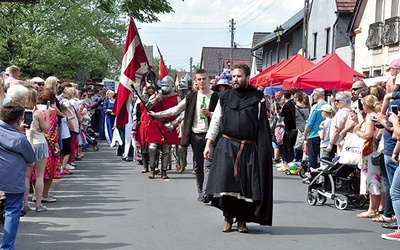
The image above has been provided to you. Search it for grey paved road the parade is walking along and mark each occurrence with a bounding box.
[0,141,400,250]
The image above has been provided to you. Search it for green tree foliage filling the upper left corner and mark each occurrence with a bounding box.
[0,0,172,81]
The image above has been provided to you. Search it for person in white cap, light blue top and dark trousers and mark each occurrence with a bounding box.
[301,88,328,178]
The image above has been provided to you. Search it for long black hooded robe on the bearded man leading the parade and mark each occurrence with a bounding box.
[206,85,273,226]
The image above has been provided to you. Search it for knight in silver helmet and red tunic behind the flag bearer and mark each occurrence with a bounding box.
[146,76,179,179]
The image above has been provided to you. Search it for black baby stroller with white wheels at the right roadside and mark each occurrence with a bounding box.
[307,157,366,210]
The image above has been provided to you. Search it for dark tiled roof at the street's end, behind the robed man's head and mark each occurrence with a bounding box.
[200,47,251,77]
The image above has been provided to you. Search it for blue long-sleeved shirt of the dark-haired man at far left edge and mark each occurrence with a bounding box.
[0,120,36,194]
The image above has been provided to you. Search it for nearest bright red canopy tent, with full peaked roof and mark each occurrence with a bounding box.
[283,53,365,91]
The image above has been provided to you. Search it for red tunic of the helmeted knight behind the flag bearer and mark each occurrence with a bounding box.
[147,95,179,145]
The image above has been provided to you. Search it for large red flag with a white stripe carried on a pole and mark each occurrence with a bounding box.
[113,17,149,128]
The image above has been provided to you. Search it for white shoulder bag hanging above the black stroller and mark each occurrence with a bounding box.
[339,133,365,165]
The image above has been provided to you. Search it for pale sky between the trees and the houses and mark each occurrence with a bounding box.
[135,0,304,71]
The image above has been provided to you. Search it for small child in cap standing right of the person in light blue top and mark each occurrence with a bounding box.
[317,104,332,170]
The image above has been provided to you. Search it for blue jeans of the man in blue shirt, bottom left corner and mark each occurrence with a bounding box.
[0,193,24,250]
